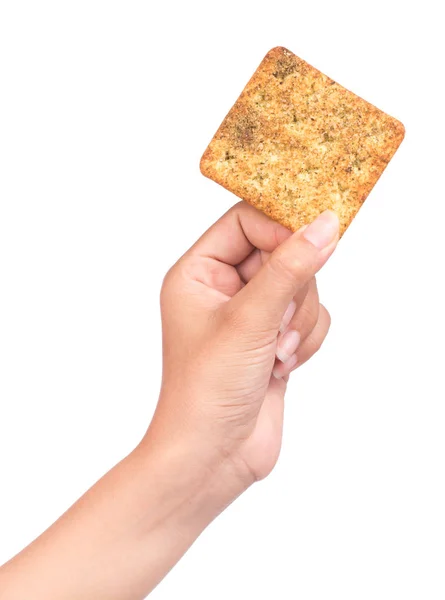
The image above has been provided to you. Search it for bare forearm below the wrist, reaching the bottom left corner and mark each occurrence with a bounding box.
[0,428,245,600]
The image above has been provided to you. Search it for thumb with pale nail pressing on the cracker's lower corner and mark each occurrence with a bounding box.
[230,210,339,331]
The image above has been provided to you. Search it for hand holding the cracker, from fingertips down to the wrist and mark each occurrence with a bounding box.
[147,202,338,487]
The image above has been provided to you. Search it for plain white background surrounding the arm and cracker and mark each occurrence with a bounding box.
[0,0,445,600]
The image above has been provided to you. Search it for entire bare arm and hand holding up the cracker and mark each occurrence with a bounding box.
[0,203,338,600]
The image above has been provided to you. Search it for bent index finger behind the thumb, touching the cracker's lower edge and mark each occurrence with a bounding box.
[187,202,292,265]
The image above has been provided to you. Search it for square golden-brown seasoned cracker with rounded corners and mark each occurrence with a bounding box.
[200,47,405,235]
